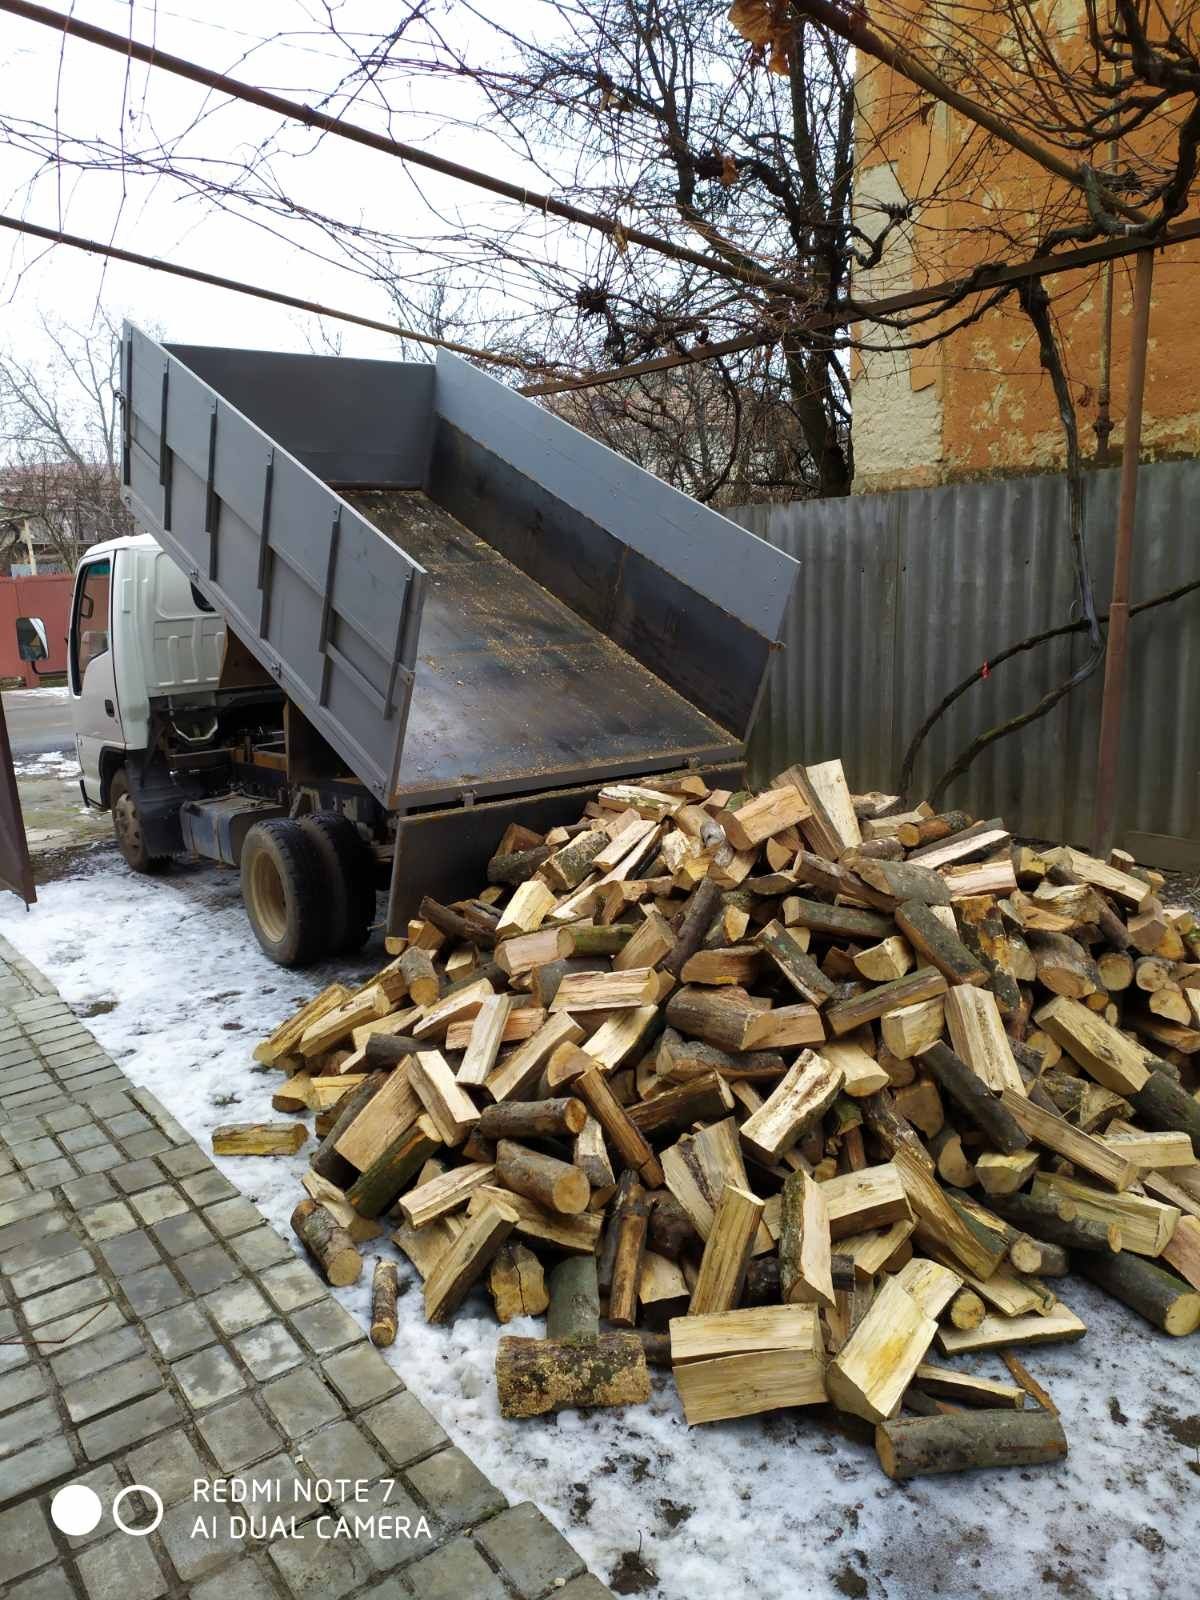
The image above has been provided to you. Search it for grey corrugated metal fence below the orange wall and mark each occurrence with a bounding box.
[726,461,1200,866]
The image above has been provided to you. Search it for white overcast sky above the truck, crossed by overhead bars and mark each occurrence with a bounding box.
[0,0,570,366]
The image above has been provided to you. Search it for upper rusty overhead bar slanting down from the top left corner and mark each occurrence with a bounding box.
[0,0,811,299]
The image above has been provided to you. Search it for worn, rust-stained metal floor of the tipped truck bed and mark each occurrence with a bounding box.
[346,491,741,805]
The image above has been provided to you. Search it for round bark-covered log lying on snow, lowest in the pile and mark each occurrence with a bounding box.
[875,1410,1067,1480]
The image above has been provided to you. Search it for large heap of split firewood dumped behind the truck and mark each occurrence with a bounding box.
[227,762,1200,1478]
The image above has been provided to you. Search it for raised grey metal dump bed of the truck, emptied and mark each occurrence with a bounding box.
[125,328,797,811]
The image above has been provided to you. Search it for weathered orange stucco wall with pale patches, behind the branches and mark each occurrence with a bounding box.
[853,0,1200,491]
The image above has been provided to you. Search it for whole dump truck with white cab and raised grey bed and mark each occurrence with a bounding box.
[51,325,798,965]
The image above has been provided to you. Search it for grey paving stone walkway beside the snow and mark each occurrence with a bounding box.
[0,939,610,1600]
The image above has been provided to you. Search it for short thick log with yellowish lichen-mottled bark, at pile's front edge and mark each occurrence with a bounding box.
[496,1333,650,1418]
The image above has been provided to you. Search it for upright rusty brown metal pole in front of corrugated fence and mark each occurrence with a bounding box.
[1091,250,1154,856]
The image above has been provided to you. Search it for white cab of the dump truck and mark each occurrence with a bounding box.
[67,533,226,810]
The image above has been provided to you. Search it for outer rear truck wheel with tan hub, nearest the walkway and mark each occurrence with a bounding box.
[242,818,328,966]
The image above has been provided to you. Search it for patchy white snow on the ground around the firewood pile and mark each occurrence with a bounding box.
[0,850,1200,1600]
